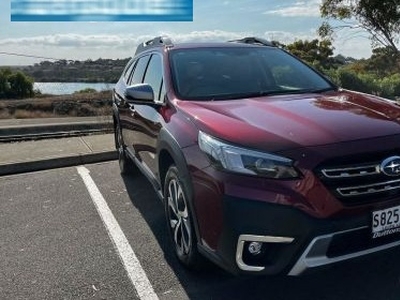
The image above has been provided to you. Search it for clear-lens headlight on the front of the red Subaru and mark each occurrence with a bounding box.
[199,131,299,179]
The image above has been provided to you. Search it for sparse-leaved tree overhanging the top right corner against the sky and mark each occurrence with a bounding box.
[319,0,400,53]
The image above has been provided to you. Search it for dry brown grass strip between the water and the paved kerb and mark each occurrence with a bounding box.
[0,91,112,119]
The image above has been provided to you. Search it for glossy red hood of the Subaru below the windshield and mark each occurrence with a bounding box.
[177,90,400,152]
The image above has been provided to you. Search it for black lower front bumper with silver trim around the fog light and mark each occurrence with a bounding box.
[208,196,400,276]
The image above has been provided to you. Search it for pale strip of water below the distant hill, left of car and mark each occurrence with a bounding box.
[33,82,115,95]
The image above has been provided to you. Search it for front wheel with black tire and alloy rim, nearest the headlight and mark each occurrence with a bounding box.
[164,165,204,270]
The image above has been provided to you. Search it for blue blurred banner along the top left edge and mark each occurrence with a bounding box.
[11,0,193,22]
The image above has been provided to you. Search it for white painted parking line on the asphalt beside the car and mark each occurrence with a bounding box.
[77,166,158,300]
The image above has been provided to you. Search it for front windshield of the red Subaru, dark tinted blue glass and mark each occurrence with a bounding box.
[171,47,334,100]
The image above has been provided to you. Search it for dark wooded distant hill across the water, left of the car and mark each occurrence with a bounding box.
[12,58,129,83]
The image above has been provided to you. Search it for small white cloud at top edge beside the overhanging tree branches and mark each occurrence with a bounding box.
[263,0,321,17]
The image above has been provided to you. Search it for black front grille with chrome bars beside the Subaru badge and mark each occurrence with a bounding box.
[315,150,400,205]
